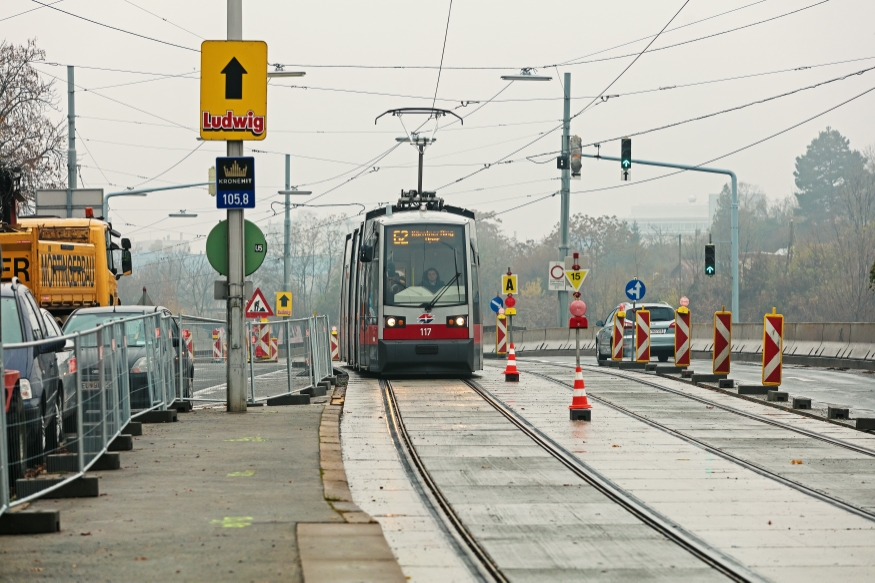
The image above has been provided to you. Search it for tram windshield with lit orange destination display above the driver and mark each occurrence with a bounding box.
[383,224,468,309]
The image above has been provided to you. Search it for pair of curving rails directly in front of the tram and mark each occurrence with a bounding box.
[380,379,761,581]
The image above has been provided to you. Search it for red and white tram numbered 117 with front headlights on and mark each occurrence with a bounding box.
[340,191,483,376]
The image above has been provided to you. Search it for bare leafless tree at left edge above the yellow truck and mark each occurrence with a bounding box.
[0,39,64,200]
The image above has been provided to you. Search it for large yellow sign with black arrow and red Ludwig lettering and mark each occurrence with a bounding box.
[200,40,267,140]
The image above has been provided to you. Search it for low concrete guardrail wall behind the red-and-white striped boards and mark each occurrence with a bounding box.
[483,320,875,366]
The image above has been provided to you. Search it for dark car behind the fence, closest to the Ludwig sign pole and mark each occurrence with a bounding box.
[63,306,194,410]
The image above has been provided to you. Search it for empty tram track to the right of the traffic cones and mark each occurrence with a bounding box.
[518,363,875,521]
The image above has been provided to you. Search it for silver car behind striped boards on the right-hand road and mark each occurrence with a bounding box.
[596,302,675,362]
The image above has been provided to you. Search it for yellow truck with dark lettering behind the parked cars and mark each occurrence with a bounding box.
[0,214,132,321]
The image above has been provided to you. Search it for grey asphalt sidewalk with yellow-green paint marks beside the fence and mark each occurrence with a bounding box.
[0,384,397,582]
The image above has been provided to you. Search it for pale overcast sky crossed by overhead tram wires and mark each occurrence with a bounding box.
[0,0,875,249]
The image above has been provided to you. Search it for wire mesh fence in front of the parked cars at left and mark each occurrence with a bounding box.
[0,314,180,512]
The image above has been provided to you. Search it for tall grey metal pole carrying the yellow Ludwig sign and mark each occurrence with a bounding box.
[227,0,248,413]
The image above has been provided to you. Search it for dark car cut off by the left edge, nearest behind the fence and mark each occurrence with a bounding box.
[0,278,64,466]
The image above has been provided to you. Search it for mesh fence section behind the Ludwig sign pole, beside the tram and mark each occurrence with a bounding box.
[177,315,333,403]
